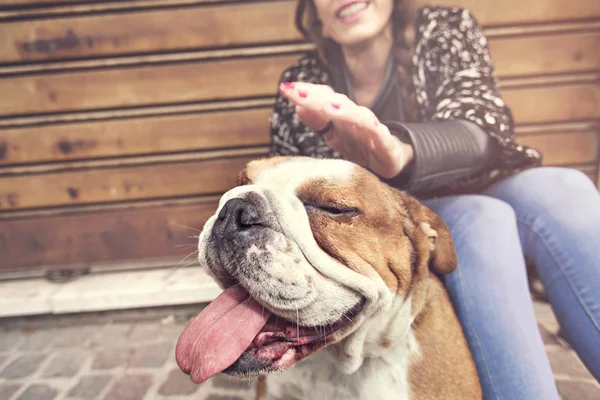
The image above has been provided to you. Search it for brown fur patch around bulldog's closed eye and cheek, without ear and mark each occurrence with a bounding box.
[297,169,414,294]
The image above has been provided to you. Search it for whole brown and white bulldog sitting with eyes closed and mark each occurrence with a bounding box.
[176,157,482,400]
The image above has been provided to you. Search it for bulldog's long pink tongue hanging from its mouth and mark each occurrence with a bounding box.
[175,285,271,383]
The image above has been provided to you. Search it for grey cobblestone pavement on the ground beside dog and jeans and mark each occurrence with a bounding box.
[0,302,600,400]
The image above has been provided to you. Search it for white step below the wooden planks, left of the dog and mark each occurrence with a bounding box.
[0,267,221,317]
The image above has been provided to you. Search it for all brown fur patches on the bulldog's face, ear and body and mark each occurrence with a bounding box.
[239,157,482,400]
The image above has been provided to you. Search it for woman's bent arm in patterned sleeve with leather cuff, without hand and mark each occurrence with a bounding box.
[387,8,541,192]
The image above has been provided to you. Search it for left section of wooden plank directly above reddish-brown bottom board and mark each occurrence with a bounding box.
[0,154,255,211]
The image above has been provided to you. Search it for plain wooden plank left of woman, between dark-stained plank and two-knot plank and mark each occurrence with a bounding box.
[0,55,297,115]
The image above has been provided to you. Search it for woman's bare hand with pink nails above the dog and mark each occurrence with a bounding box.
[279,82,414,179]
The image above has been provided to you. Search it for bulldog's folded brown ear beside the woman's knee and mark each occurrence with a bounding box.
[404,195,458,274]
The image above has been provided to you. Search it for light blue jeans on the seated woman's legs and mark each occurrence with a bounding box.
[425,168,600,400]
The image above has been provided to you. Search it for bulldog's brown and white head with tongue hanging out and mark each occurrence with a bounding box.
[177,157,456,382]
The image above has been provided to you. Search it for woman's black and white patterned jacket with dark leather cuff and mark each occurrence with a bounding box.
[270,7,541,197]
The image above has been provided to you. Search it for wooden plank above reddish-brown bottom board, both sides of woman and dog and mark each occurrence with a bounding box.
[0,128,598,211]
